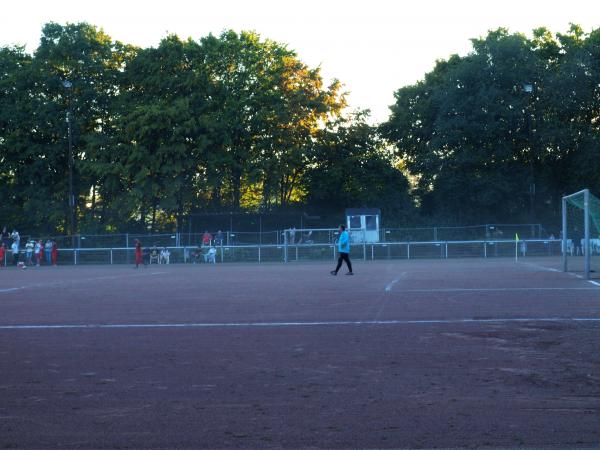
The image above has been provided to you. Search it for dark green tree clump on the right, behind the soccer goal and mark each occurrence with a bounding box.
[381,26,600,224]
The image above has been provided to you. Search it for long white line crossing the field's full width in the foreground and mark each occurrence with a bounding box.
[0,317,600,331]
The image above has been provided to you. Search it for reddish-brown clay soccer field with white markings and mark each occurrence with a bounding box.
[0,259,600,449]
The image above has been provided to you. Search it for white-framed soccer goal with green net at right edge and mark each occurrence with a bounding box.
[562,189,600,279]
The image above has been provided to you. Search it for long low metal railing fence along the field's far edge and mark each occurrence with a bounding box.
[4,239,562,265]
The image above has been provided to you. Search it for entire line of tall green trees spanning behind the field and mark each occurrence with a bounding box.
[0,23,600,233]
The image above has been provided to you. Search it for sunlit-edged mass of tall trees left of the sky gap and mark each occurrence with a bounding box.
[0,23,408,232]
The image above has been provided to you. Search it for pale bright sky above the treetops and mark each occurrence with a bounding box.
[0,0,600,122]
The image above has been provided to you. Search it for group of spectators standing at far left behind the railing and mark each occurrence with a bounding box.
[0,226,58,268]
